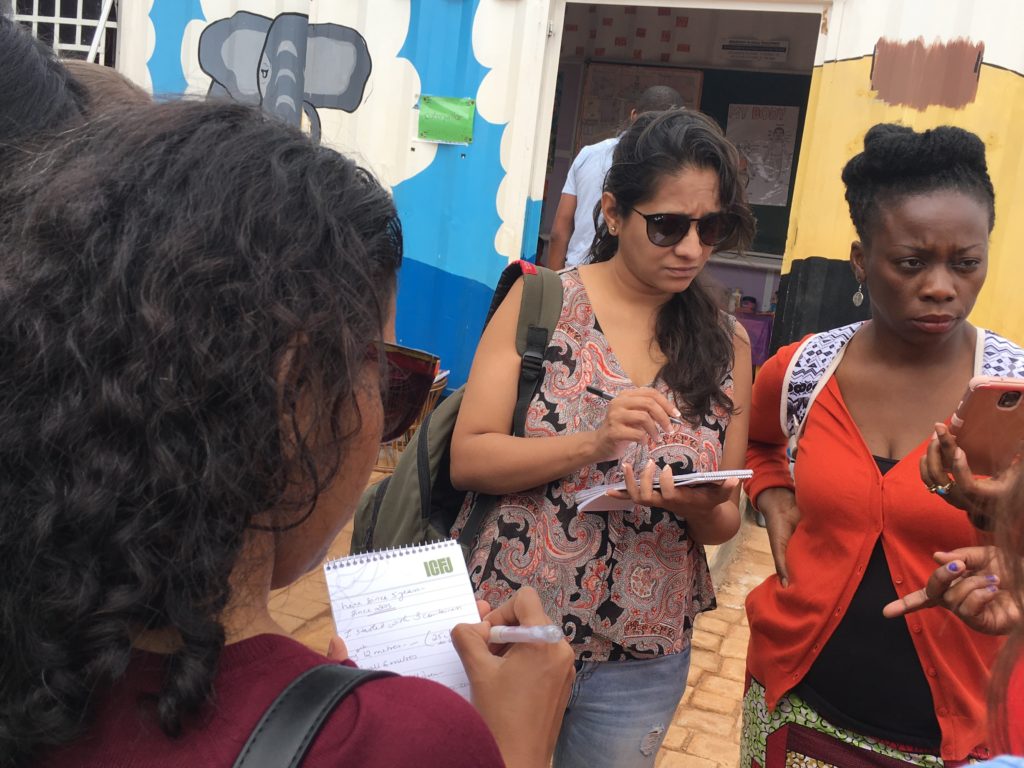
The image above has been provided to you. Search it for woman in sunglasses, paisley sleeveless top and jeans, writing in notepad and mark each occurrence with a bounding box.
[452,110,754,768]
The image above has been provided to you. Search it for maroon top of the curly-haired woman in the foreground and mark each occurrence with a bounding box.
[39,635,504,768]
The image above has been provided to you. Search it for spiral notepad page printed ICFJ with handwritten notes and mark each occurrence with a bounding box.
[324,540,480,698]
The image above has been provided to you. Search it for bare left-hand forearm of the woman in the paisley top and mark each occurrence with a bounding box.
[452,432,599,495]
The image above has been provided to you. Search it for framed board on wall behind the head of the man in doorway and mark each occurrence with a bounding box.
[573,62,703,155]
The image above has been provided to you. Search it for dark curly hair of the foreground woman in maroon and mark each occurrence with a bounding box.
[0,102,401,766]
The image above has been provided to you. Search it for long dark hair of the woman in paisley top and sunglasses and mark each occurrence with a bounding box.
[591,110,754,422]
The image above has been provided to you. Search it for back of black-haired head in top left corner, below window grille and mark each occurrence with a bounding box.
[0,12,84,145]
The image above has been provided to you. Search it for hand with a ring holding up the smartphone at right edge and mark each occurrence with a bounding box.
[921,424,1020,524]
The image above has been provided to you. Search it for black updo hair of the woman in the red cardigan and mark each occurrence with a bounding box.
[843,123,995,244]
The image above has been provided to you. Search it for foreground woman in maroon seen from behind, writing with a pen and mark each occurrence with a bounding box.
[0,102,572,768]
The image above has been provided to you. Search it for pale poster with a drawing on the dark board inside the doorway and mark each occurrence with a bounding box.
[725,104,800,206]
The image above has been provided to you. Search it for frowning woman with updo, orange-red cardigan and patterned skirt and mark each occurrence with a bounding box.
[740,125,1024,768]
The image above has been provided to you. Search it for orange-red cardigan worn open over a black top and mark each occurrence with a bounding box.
[746,344,1002,760]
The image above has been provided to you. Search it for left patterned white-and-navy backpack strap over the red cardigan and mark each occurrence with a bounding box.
[779,323,863,476]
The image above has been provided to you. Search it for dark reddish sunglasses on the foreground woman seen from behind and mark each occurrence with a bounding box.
[375,341,439,442]
